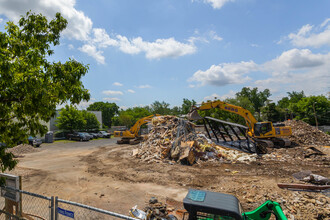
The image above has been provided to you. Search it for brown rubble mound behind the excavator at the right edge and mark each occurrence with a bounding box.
[285,120,330,145]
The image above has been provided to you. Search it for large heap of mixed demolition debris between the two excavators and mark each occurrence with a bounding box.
[135,116,256,164]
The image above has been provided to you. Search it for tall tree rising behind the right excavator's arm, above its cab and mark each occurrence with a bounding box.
[236,87,271,120]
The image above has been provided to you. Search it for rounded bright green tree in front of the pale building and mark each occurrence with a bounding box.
[56,105,85,132]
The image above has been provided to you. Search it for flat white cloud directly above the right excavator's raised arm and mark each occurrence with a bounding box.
[188,61,258,86]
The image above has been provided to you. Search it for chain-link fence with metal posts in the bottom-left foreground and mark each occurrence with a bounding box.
[0,187,137,220]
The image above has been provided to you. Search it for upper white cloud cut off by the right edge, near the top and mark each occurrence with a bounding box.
[288,18,330,48]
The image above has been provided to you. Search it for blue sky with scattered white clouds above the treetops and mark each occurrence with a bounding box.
[0,0,330,109]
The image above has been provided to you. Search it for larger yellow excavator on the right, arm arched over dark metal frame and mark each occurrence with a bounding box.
[187,100,292,148]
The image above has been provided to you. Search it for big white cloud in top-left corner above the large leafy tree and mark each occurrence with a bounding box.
[0,0,93,40]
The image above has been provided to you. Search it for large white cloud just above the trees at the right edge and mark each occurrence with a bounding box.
[255,49,330,95]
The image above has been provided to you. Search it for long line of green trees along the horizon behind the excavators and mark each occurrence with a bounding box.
[62,87,330,128]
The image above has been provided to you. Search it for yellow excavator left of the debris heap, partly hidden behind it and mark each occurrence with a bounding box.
[114,114,160,145]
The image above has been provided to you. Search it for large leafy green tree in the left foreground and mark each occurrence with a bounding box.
[0,12,90,171]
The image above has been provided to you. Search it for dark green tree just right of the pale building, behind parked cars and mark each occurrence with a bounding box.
[87,102,119,127]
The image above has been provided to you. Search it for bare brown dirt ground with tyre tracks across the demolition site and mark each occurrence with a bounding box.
[7,140,330,219]
